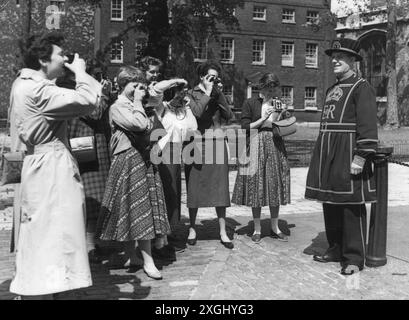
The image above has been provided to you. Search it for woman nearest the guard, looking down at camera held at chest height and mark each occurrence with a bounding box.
[232,73,290,242]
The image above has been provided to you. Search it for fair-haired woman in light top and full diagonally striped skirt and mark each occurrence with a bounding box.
[97,66,170,280]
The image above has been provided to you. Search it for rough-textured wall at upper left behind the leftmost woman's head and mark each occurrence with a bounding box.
[0,0,95,119]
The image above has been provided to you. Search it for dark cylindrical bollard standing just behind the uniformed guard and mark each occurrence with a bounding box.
[365,146,393,268]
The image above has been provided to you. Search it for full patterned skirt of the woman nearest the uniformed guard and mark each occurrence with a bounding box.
[232,131,290,208]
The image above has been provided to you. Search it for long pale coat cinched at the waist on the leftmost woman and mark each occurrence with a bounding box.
[10,69,101,296]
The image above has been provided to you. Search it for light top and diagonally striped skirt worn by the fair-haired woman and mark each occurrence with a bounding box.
[96,95,170,242]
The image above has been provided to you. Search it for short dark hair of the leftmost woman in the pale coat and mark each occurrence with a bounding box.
[20,32,64,70]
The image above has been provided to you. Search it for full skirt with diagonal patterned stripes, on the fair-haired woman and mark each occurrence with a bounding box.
[97,148,170,241]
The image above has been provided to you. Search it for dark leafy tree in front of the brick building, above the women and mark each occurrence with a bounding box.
[94,0,244,80]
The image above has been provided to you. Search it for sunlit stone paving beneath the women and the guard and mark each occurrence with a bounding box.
[0,164,409,300]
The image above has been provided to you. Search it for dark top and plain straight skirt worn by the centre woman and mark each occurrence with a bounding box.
[184,86,233,208]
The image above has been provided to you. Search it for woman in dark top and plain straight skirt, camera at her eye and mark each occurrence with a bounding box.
[185,62,234,249]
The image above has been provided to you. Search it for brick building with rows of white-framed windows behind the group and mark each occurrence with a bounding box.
[97,0,335,121]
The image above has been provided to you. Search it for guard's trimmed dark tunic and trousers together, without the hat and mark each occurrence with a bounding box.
[305,38,378,269]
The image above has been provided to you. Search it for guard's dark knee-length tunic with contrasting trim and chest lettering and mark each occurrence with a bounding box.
[305,75,378,204]
